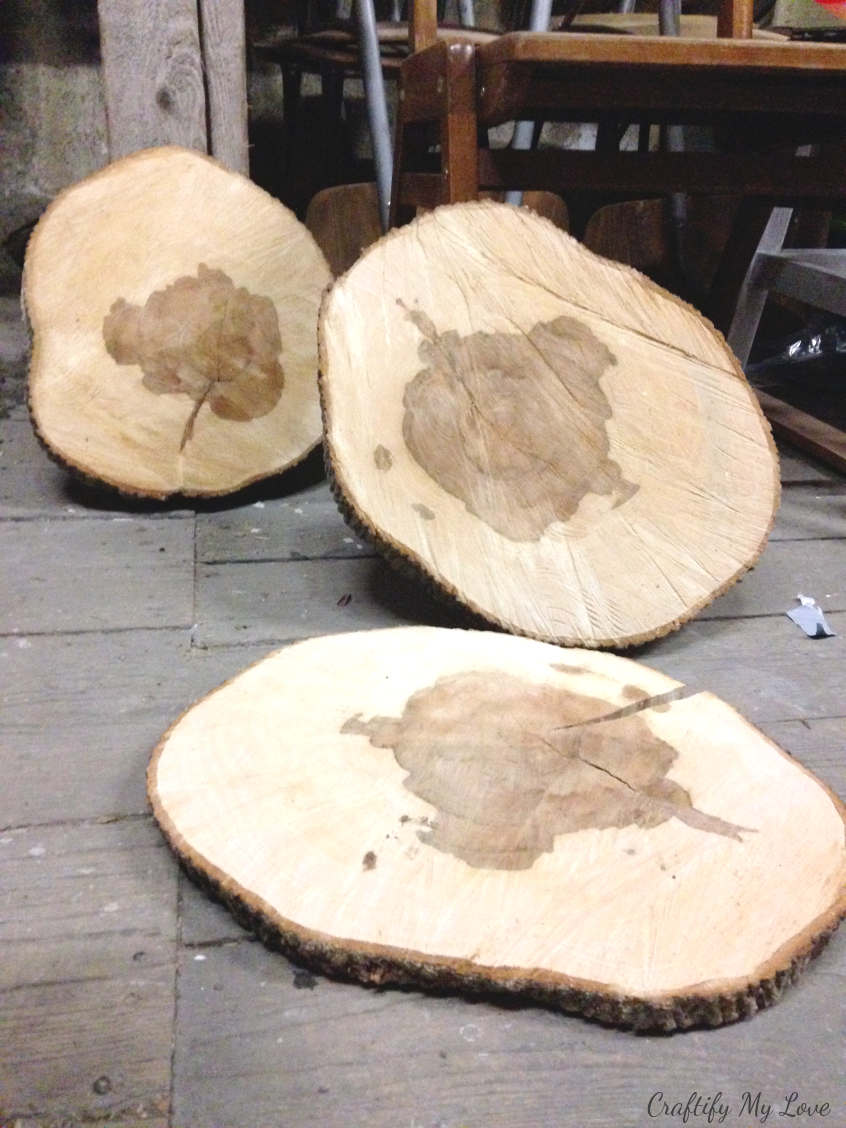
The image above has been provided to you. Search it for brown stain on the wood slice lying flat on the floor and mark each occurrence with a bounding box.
[341,671,748,870]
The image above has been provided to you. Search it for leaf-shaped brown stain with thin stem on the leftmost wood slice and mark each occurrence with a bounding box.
[103,263,284,450]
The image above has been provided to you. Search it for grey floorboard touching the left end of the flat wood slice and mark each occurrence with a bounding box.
[0,627,267,828]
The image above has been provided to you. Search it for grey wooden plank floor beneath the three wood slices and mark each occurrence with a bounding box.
[0,302,846,1128]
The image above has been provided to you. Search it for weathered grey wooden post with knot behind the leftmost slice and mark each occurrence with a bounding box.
[97,0,206,160]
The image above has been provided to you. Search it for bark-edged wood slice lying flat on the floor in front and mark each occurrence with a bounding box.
[148,627,846,1030]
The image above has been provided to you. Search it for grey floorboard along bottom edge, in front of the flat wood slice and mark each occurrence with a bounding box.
[174,936,846,1128]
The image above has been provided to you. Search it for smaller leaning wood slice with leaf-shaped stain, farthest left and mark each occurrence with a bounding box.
[24,148,331,497]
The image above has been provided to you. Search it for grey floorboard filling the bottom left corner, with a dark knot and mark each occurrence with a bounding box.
[0,818,176,1128]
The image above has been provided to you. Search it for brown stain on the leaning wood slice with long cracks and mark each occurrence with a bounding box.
[403,310,638,540]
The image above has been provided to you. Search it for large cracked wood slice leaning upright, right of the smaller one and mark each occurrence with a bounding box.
[320,203,779,646]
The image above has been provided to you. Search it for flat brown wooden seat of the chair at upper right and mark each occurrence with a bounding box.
[475,32,846,124]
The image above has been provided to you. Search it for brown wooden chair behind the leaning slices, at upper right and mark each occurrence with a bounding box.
[391,0,846,329]
